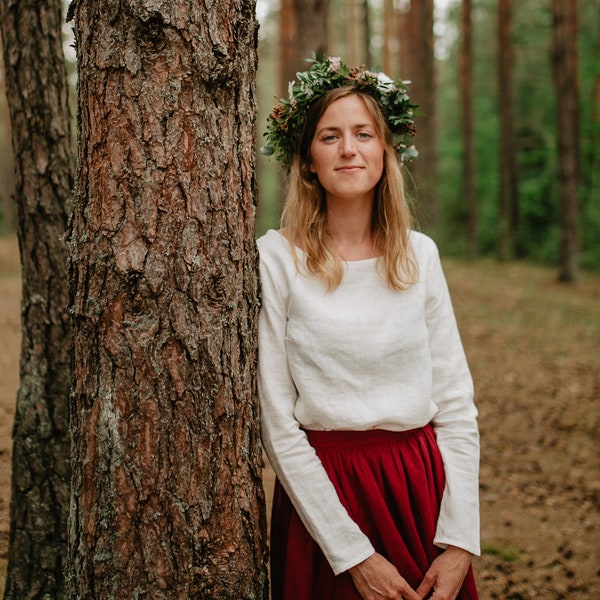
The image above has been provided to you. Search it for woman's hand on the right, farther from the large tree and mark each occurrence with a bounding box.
[417,546,473,600]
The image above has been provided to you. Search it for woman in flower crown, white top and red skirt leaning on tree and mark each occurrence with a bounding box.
[258,58,479,600]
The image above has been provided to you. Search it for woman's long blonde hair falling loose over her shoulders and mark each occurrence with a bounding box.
[281,86,418,290]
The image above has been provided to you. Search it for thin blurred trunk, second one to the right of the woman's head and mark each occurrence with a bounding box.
[459,0,479,258]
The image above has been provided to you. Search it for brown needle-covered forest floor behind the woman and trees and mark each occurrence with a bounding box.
[0,233,600,600]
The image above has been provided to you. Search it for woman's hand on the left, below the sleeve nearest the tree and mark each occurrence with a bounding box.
[348,553,421,600]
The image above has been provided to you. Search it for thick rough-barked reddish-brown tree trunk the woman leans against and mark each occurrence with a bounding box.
[69,0,268,600]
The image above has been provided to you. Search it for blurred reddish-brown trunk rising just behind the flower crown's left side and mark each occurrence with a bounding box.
[279,0,329,96]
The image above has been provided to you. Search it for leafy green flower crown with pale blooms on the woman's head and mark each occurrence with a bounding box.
[260,53,418,169]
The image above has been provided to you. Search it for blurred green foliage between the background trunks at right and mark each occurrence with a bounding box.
[438,0,600,269]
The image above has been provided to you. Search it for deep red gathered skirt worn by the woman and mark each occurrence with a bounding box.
[271,425,478,600]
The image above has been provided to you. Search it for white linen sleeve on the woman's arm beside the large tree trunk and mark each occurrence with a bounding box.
[258,233,374,574]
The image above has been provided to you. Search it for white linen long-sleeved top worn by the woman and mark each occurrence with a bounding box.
[258,230,480,574]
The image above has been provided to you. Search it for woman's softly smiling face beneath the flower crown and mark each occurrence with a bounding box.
[310,94,384,206]
